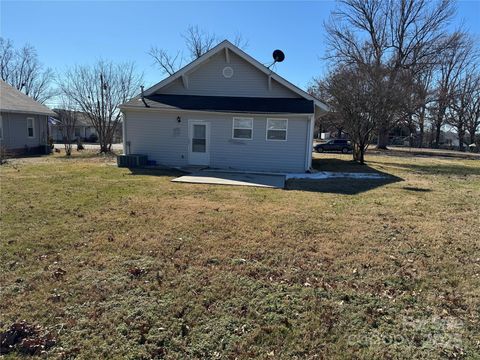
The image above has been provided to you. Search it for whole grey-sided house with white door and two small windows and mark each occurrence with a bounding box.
[120,40,327,172]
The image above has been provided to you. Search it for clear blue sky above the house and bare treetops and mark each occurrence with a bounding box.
[0,0,480,94]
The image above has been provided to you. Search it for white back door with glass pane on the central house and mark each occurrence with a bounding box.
[188,120,210,165]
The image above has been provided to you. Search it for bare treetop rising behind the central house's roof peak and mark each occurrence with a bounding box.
[148,25,248,75]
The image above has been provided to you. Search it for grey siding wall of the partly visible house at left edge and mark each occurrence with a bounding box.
[0,112,47,149]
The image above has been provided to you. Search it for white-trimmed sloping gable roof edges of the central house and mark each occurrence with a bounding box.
[124,40,328,111]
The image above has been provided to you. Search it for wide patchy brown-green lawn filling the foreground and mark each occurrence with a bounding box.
[0,155,480,359]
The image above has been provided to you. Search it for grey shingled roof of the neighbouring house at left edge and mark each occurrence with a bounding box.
[0,80,55,116]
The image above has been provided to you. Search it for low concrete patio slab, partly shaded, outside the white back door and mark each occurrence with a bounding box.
[172,171,285,189]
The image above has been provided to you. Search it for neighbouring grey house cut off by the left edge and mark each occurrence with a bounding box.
[0,80,55,155]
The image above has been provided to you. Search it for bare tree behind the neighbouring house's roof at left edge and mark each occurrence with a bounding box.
[0,38,56,103]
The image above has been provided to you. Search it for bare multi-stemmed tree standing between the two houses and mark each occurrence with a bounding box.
[59,61,143,153]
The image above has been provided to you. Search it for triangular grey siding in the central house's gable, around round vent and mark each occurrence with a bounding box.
[157,51,300,98]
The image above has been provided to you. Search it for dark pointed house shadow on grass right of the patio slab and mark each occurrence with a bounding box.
[285,159,403,195]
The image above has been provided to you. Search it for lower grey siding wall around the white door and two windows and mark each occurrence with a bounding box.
[125,111,308,172]
